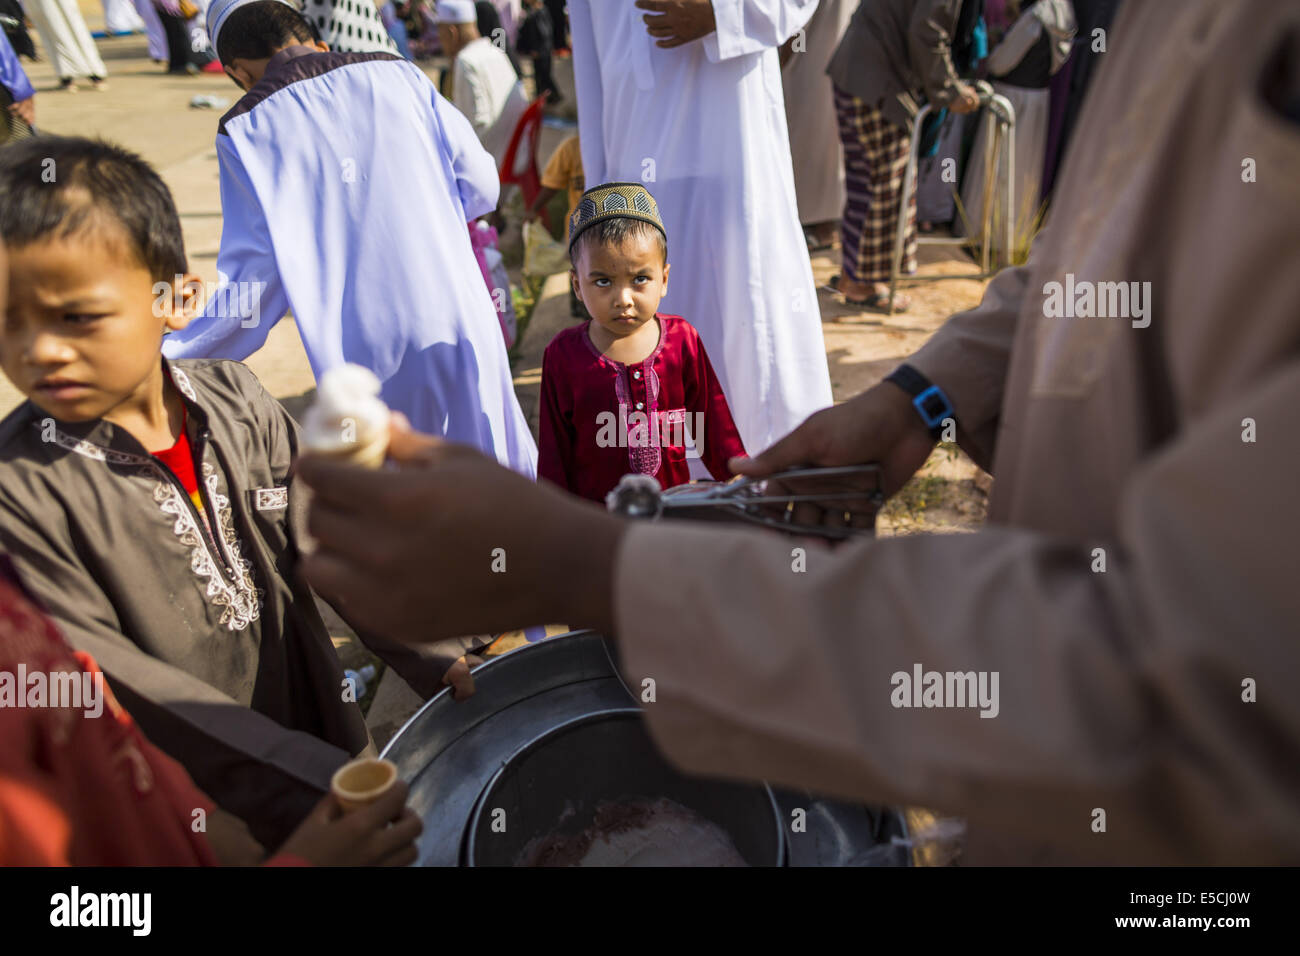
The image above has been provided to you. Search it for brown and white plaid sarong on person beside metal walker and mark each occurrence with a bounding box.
[835,86,917,282]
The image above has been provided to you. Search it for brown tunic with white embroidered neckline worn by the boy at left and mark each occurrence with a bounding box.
[0,360,463,844]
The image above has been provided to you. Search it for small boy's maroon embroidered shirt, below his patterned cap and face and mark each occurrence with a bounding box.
[537,315,745,502]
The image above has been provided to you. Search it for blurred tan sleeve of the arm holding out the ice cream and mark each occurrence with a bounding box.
[615,360,1300,864]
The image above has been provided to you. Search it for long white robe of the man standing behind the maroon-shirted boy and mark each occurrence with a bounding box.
[568,0,831,454]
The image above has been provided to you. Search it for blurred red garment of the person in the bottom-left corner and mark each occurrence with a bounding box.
[0,559,217,866]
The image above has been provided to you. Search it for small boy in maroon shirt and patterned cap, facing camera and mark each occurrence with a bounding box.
[538,182,745,502]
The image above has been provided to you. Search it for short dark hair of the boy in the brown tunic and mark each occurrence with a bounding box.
[0,135,186,281]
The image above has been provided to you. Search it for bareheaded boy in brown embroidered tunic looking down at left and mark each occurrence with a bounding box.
[0,137,475,843]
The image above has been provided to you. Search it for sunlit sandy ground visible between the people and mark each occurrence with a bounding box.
[0,26,988,745]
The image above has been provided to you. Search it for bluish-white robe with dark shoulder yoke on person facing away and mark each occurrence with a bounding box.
[163,53,537,477]
